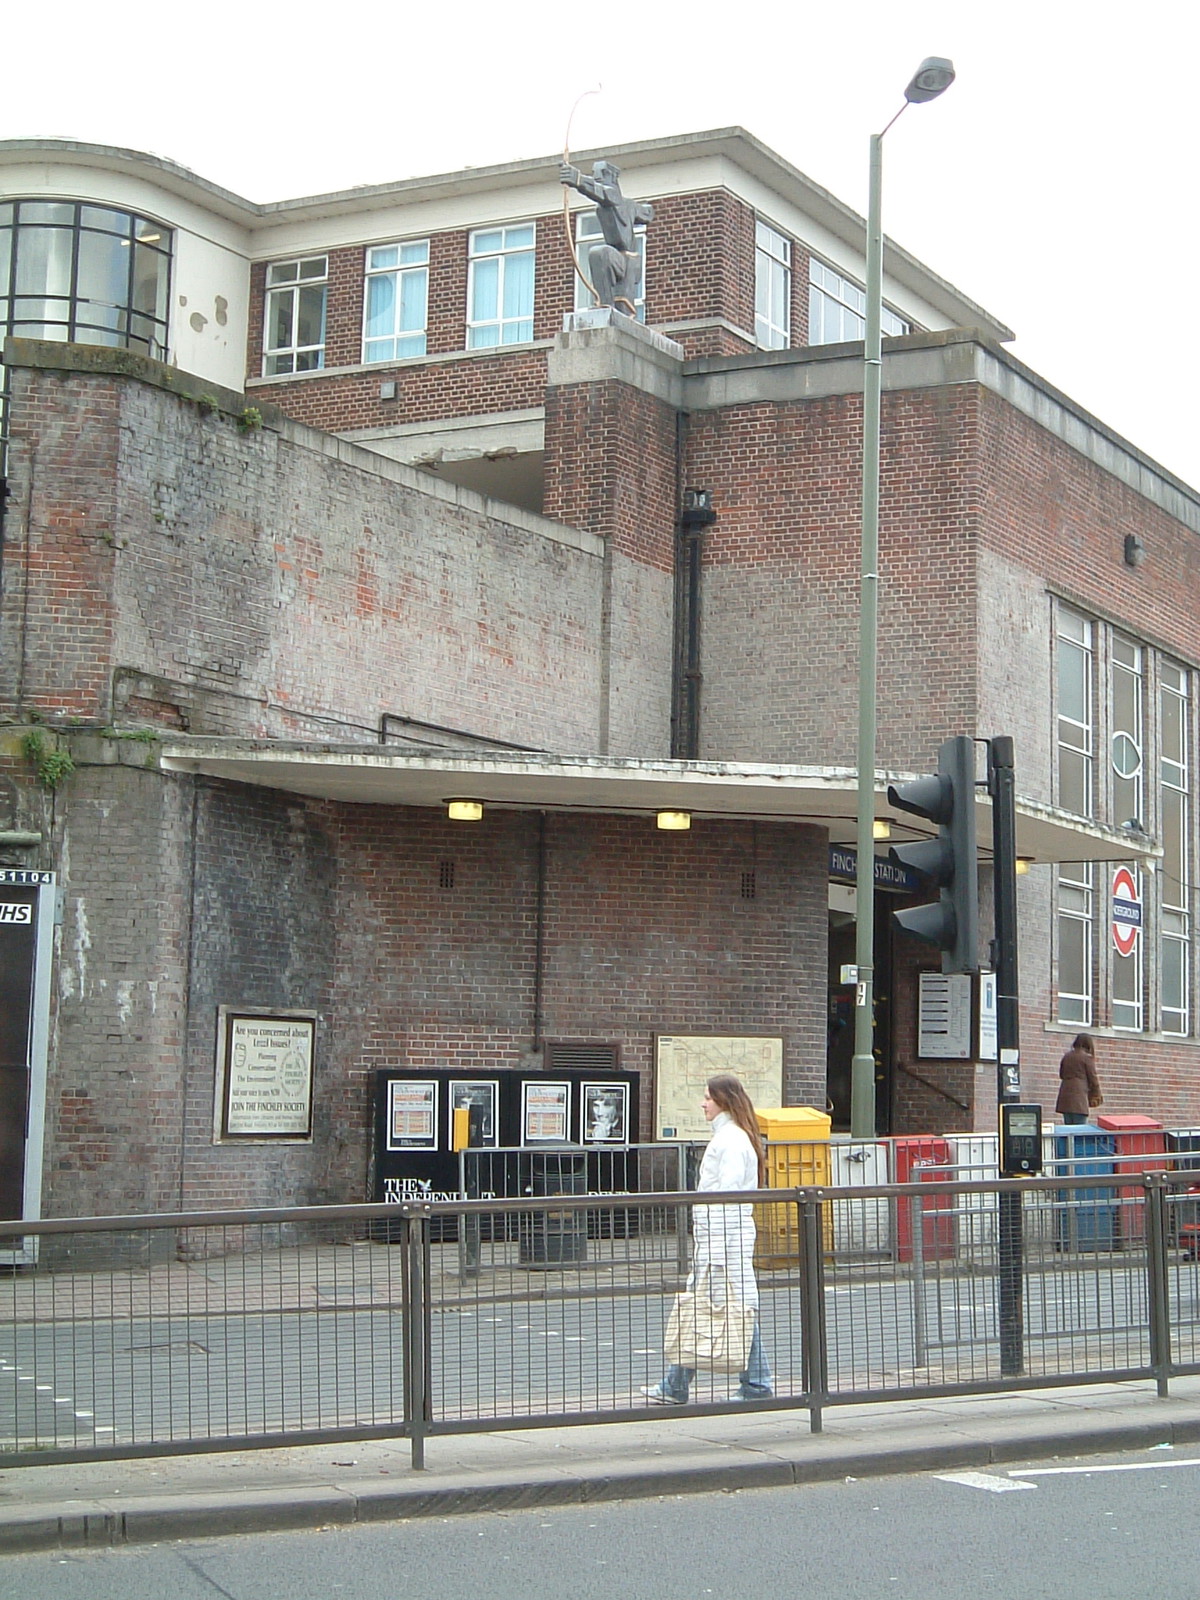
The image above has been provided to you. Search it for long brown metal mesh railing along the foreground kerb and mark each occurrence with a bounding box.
[0,1162,1200,1466]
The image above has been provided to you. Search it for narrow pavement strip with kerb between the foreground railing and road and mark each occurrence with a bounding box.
[0,1376,1200,1552]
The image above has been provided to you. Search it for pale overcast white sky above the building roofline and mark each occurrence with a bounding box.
[0,0,1200,488]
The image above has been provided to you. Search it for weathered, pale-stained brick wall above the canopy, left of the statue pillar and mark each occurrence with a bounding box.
[0,352,611,750]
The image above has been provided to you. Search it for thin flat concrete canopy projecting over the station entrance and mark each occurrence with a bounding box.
[160,738,1160,862]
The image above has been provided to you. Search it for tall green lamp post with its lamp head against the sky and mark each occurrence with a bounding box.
[850,56,954,1139]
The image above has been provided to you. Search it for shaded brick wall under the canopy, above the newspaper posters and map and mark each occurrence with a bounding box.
[334,808,826,1136]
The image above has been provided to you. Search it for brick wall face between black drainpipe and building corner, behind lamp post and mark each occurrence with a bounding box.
[686,386,979,768]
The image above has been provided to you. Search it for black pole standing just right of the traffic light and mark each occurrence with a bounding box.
[987,734,1026,1378]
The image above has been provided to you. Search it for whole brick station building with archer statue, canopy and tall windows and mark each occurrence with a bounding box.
[0,130,1200,1216]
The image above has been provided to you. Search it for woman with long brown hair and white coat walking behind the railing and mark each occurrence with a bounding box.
[642,1074,771,1405]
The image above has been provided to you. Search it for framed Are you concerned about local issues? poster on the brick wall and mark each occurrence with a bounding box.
[216,1006,317,1139]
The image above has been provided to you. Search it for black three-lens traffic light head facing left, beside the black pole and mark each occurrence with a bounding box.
[888,736,979,973]
